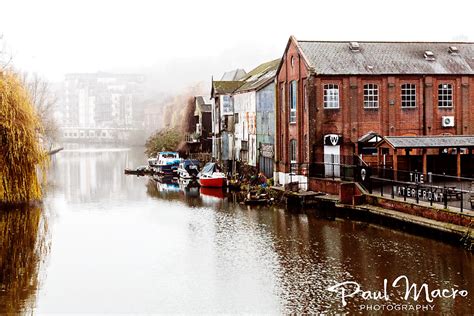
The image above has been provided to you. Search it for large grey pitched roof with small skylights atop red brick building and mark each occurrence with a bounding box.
[298,41,474,75]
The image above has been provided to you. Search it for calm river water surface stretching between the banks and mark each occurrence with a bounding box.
[0,147,474,314]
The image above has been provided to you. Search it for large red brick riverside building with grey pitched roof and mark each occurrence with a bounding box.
[275,37,474,188]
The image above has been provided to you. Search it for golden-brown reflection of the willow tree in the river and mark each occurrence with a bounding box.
[0,205,50,314]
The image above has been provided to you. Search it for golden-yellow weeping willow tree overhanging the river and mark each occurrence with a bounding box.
[0,72,47,204]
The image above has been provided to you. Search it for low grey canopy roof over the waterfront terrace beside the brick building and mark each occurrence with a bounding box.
[384,135,474,148]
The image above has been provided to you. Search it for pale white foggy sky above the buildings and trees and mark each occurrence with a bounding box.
[0,0,474,91]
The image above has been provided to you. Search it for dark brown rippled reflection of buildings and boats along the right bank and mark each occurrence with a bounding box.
[147,177,474,314]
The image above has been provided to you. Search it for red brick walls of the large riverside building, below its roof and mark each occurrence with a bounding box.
[275,40,474,172]
